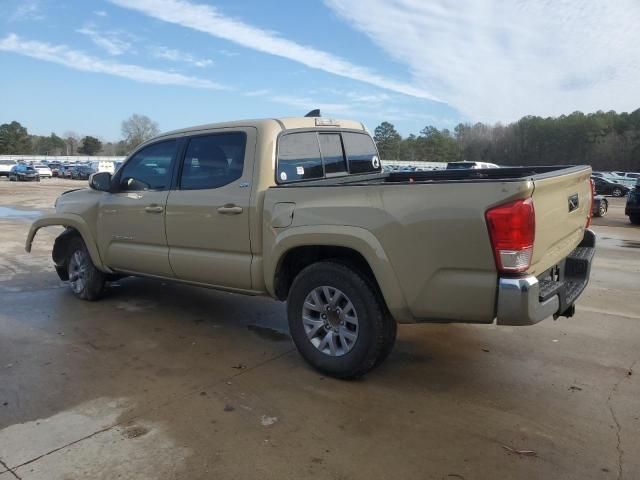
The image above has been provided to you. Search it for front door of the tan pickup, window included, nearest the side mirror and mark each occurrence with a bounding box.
[98,139,178,277]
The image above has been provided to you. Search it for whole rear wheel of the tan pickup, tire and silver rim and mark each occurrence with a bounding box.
[287,261,395,378]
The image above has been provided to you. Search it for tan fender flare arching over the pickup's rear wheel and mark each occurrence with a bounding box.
[264,225,415,322]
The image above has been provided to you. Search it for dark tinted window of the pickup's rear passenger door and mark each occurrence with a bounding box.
[180,132,247,190]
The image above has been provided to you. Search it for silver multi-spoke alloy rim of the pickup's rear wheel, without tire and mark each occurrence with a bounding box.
[302,286,359,357]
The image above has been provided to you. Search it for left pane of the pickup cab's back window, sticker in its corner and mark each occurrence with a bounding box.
[277,132,324,183]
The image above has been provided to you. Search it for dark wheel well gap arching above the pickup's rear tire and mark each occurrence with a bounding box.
[274,245,383,300]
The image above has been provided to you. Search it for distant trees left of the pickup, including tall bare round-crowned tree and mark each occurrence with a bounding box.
[0,114,160,156]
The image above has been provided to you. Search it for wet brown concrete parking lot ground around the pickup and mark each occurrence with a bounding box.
[0,178,640,480]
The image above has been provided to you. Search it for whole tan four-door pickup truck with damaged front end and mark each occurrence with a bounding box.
[26,117,595,378]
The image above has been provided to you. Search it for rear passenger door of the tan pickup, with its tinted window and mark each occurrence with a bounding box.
[166,128,256,290]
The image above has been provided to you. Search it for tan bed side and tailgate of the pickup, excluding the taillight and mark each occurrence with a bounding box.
[263,166,591,323]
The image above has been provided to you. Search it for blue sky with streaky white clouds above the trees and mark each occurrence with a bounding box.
[0,0,640,140]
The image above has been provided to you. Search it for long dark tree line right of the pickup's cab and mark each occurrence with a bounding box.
[374,109,640,171]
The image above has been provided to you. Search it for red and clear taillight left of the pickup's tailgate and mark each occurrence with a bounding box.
[485,198,536,273]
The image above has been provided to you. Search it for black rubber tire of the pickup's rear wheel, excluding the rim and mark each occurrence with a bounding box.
[287,261,396,379]
